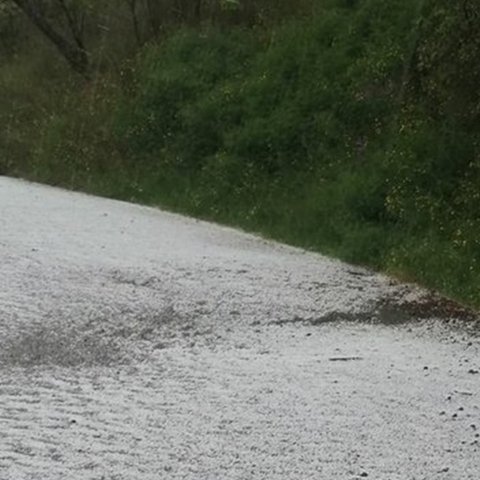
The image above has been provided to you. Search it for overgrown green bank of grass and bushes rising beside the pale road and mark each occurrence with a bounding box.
[0,0,480,307]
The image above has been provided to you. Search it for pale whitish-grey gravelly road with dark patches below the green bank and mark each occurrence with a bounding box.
[0,177,480,480]
